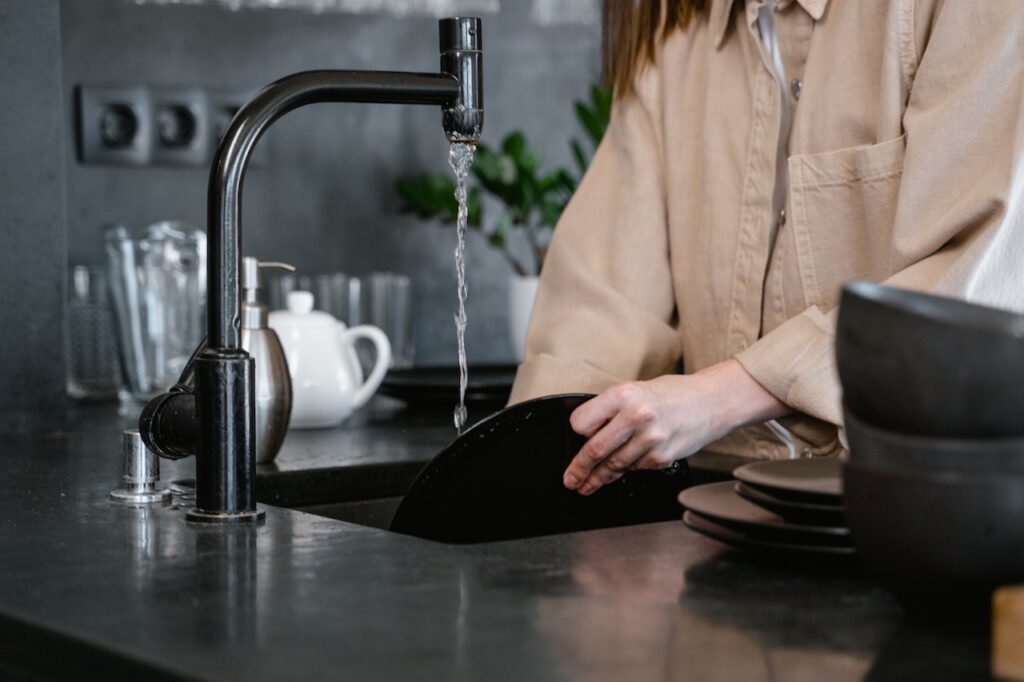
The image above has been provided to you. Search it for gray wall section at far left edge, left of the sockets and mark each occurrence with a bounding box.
[0,0,67,433]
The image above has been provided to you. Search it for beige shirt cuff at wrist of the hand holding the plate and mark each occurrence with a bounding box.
[736,307,843,425]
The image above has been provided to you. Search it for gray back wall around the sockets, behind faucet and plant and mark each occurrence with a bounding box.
[60,0,599,364]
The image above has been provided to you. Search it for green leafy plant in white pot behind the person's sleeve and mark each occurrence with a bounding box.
[395,85,611,359]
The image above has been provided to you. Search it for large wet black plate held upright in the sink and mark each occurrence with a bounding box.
[391,394,689,543]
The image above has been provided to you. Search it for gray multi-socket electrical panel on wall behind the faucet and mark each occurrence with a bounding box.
[76,85,266,167]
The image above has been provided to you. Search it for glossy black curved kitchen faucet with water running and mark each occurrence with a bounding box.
[139,17,483,522]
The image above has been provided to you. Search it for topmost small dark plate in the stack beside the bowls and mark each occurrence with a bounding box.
[732,457,843,506]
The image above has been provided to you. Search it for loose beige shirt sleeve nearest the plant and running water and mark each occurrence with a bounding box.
[510,75,681,402]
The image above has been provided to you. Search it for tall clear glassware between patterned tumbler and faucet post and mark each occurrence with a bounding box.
[105,222,206,409]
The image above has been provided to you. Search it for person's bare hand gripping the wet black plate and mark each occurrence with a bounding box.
[562,359,793,495]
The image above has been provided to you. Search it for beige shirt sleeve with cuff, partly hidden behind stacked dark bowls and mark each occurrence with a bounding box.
[736,0,1024,424]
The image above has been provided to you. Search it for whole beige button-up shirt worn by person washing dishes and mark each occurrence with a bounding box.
[512,0,1024,457]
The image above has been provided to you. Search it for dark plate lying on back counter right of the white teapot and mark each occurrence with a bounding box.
[379,365,517,404]
